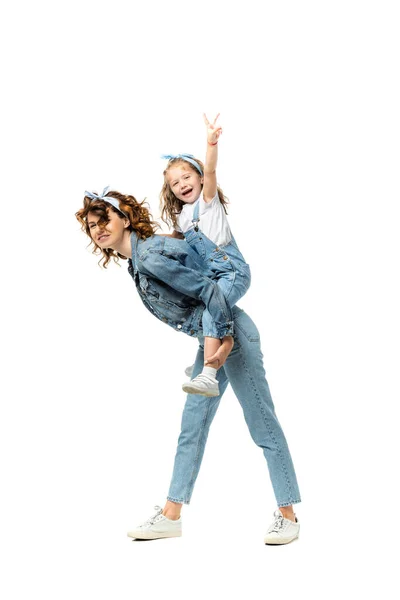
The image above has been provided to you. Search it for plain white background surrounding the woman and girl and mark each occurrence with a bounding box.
[0,0,400,600]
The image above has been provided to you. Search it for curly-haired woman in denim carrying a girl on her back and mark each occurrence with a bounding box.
[76,188,301,544]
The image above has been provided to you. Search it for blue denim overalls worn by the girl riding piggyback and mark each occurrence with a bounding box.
[183,202,251,338]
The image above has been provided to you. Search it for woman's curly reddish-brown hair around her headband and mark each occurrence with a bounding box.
[75,190,160,269]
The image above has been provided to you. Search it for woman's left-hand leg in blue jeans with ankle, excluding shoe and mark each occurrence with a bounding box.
[164,346,228,502]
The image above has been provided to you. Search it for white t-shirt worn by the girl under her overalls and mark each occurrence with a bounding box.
[175,192,232,246]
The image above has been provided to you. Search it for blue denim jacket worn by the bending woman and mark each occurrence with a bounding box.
[128,232,233,338]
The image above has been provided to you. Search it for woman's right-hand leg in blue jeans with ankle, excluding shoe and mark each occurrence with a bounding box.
[224,307,301,508]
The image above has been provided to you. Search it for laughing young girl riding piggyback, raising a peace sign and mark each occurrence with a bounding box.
[160,114,250,396]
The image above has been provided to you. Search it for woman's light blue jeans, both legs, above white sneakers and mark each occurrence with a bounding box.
[168,306,301,506]
